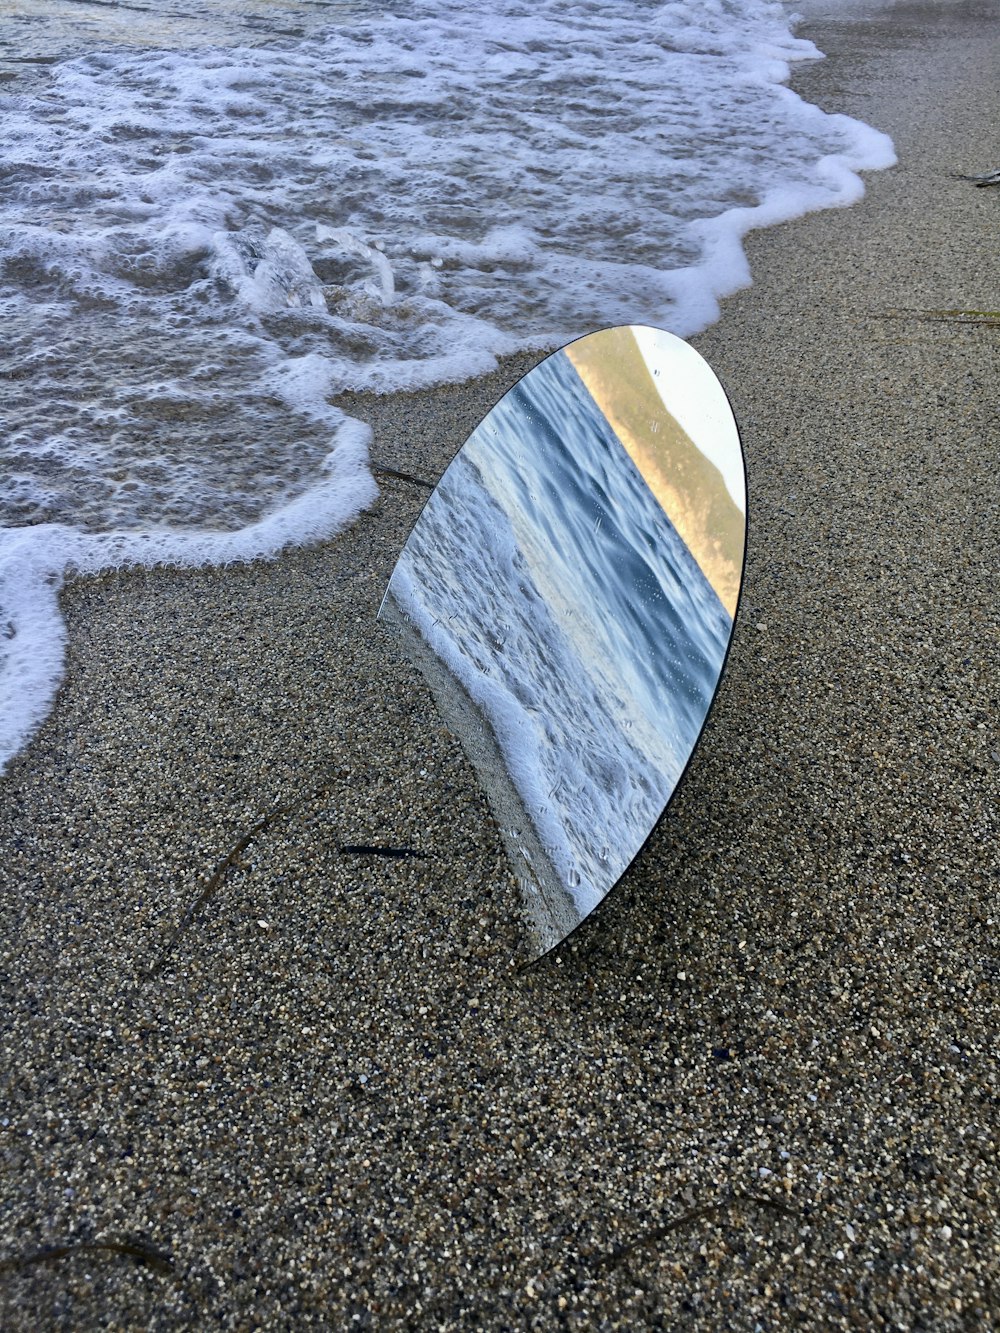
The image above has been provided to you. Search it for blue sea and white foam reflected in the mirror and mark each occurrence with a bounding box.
[389,352,732,917]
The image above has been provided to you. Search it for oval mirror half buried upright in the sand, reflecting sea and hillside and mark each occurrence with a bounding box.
[379,325,747,956]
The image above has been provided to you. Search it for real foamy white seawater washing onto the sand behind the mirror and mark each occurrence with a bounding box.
[0,0,892,766]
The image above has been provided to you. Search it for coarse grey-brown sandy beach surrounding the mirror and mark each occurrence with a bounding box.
[0,3,1000,1330]
